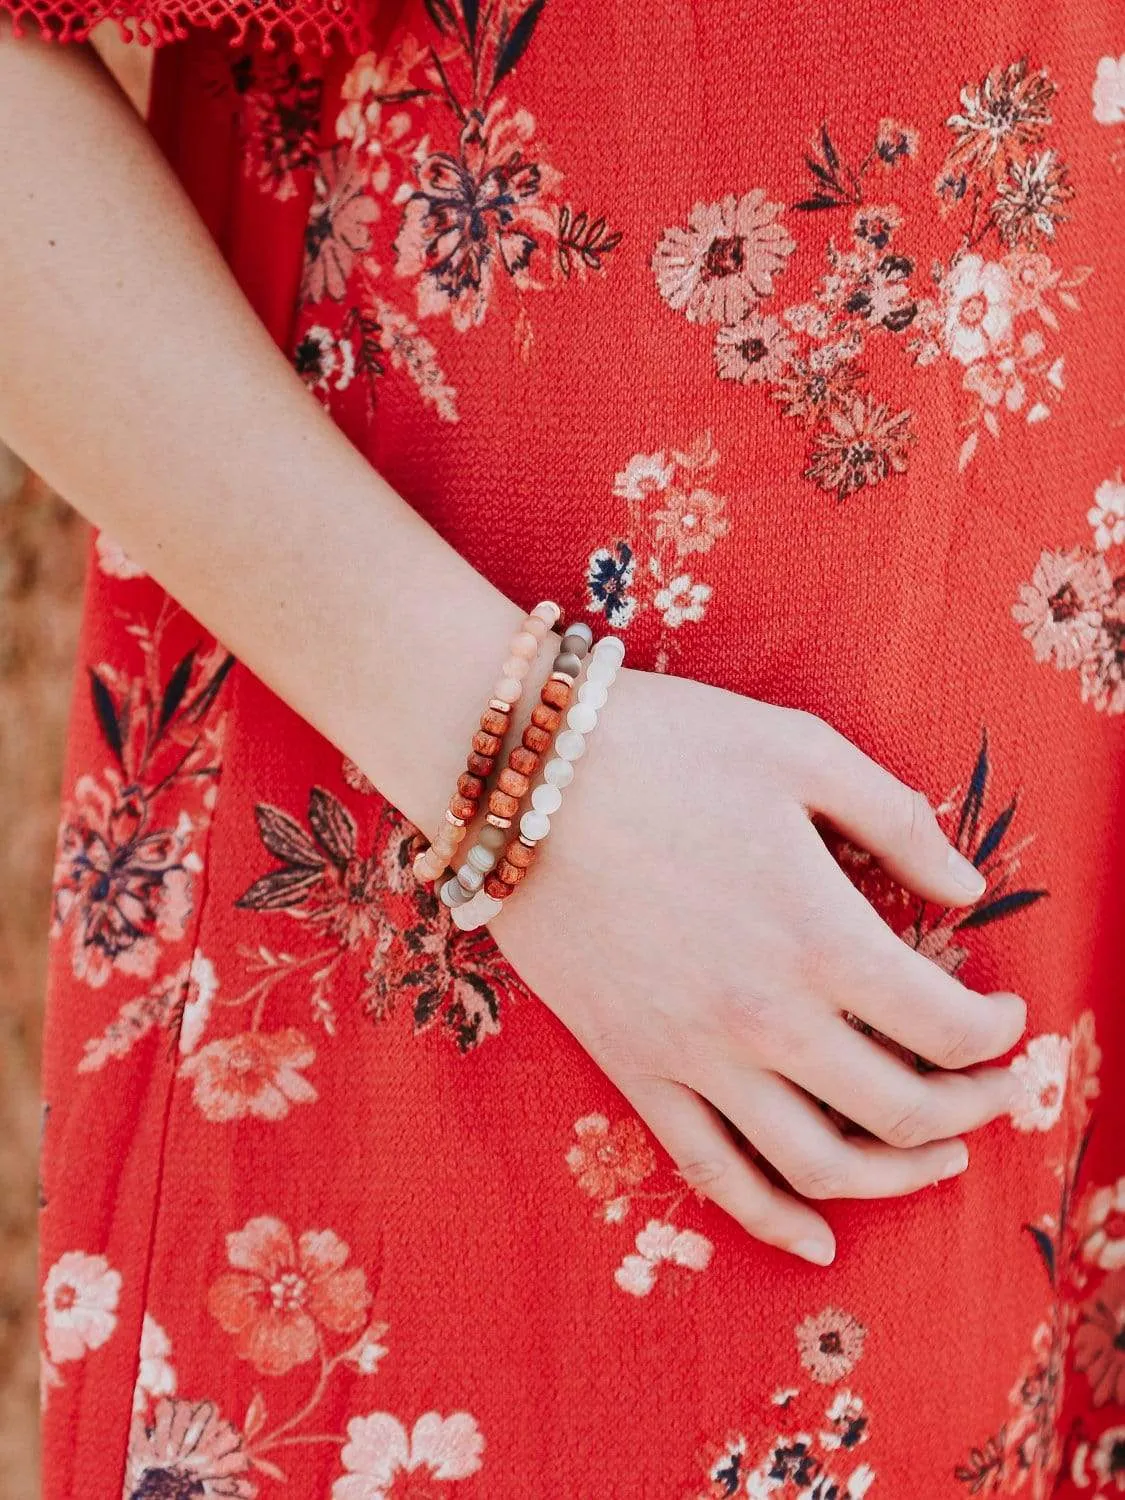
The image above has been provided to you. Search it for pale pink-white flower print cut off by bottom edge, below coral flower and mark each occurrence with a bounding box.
[332,1412,485,1500]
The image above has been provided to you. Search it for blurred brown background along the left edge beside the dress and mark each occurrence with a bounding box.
[0,29,150,1500]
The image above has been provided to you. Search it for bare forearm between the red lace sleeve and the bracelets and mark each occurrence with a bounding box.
[0,33,534,824]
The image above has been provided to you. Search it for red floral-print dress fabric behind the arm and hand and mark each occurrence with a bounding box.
[30,0,1125,1500]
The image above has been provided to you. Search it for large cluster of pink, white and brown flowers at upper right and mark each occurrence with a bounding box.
[651,60,1092,500]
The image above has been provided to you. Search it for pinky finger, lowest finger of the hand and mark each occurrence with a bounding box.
[618,1079,836,1266]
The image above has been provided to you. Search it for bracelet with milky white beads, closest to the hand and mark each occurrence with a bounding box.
[441,627,626,932]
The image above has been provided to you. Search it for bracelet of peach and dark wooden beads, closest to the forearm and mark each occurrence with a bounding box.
[414,600,563,884]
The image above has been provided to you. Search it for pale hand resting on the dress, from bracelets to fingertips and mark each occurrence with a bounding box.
[495,671,1026,1265]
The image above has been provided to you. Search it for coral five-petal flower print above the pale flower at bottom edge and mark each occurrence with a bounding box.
[207,1217,371,1376]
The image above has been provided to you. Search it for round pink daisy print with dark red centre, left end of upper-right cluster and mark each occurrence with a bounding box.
[653,188,797,324]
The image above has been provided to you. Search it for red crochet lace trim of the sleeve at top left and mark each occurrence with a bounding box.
[0,0,378,53]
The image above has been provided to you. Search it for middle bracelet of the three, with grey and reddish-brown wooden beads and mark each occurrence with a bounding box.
[441,624,594,920]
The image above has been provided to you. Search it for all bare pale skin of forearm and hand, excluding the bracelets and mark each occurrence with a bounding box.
[0,20,1026,1265]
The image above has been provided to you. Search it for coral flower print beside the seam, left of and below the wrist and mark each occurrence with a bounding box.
[180,1029,317,1124]
